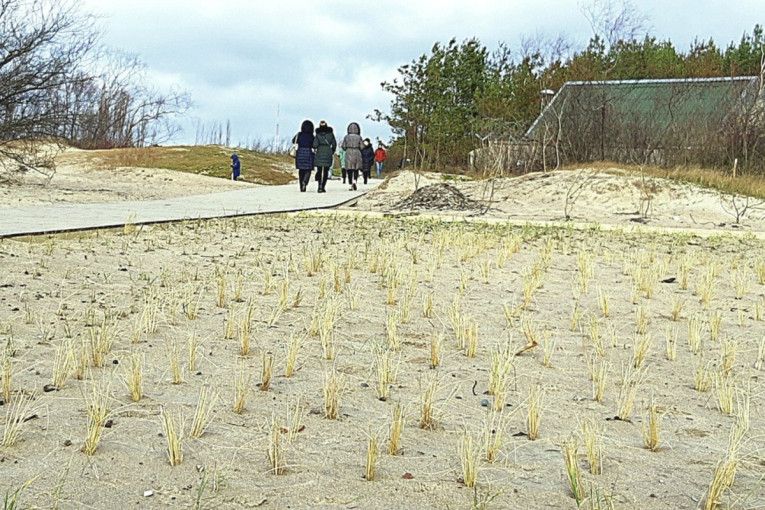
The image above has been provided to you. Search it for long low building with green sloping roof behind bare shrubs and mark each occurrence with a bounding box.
[525,76,765,170]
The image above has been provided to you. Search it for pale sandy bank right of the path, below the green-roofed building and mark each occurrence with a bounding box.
[350,169,765,231]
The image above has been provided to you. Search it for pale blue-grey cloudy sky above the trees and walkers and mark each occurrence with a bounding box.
[82,0,765,145]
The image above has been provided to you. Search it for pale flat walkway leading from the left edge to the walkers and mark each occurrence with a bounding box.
[0,179,370,238]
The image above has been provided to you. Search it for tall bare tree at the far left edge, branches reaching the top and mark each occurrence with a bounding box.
[0,0,96,179]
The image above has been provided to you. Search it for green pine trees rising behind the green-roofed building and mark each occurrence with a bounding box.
[378,0,765,167]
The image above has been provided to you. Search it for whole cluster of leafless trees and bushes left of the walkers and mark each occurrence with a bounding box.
[0,0,189,181]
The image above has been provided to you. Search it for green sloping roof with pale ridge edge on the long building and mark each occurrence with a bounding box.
[526,76,757,143]
